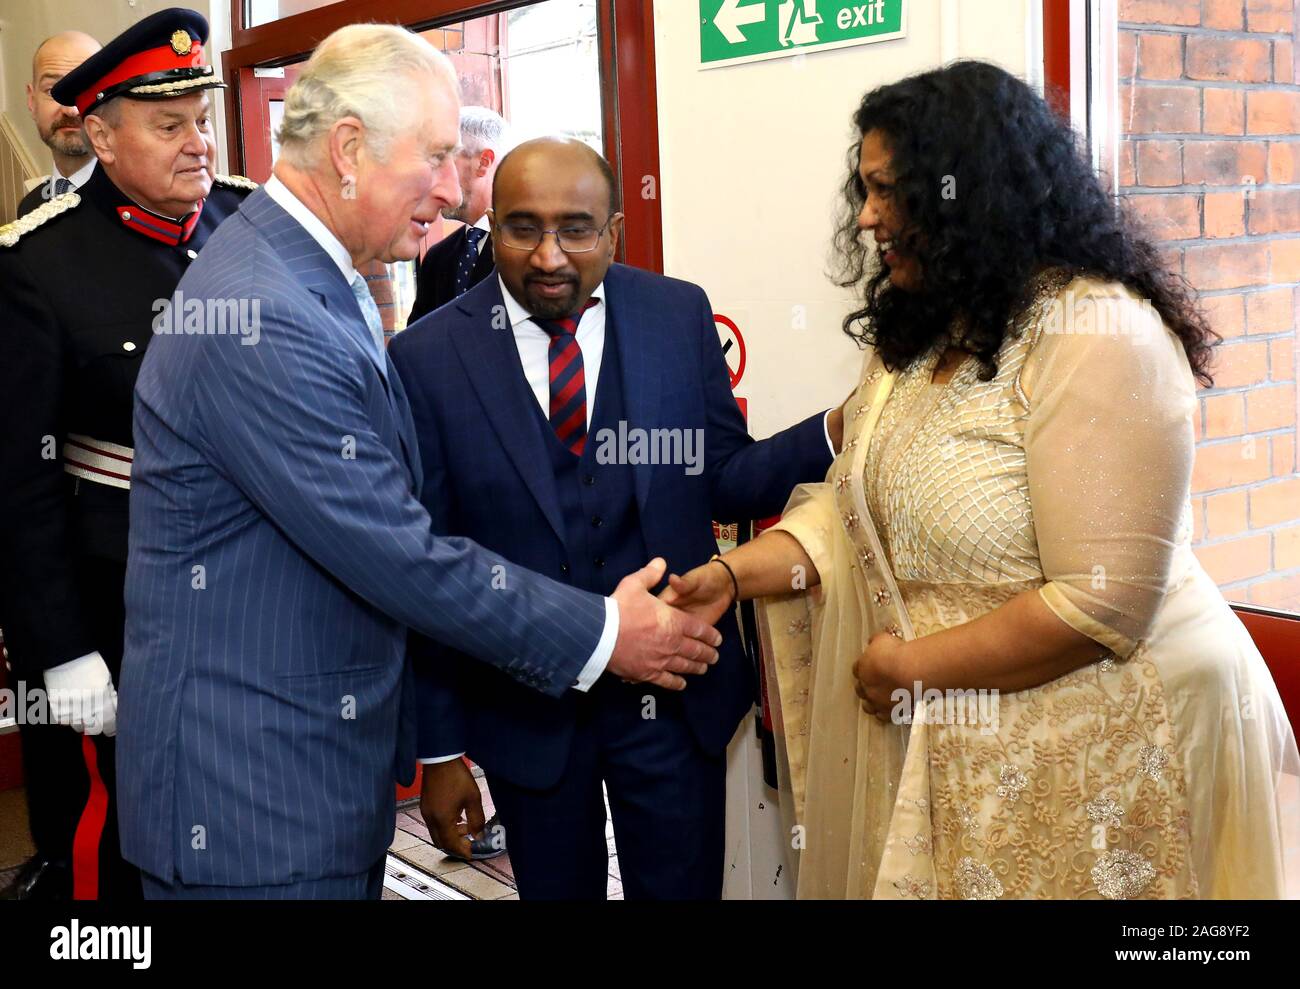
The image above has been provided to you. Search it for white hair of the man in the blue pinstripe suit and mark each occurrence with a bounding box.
[277,23,458,166]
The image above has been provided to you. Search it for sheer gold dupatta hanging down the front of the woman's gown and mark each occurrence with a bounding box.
[758,355,936,899]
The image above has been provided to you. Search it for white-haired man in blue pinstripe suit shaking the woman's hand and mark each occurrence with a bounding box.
[118,25,720,898]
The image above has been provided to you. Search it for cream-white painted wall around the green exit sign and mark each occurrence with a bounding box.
[654,0,1043,898]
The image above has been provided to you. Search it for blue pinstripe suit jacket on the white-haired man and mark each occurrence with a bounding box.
[117,191,605,885]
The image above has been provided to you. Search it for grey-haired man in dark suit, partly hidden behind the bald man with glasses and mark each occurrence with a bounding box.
[407,107,511,322]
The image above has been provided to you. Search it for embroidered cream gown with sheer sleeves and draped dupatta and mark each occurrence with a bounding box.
[761,272,1300,899]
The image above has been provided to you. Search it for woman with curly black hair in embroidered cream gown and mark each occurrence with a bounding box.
[666,62,1300,899]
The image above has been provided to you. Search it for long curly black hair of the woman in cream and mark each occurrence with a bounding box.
[835,61,1219,385]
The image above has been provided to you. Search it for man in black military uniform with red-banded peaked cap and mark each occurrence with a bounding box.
[0,9,254,899]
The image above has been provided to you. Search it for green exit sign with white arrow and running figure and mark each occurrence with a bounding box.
[699,0,906,69]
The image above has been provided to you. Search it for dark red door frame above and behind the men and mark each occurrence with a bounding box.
[221,0,663,272]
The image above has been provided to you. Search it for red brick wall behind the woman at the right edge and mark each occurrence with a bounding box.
[1119,0,1300,610]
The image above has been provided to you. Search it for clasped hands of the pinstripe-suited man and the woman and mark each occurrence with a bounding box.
[606,558,736,690]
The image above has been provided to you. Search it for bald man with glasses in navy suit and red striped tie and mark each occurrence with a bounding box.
[391,139,842,899]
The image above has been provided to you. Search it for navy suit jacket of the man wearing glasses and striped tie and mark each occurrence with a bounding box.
[389,264,831,788]
